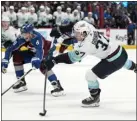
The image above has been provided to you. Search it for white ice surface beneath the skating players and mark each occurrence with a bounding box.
[2,50,136,120]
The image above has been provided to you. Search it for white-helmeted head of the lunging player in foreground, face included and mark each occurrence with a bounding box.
[73,21,91,41]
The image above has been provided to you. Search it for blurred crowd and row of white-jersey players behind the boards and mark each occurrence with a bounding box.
[1,1,137,45]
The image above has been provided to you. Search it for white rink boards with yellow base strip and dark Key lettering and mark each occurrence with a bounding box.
[2,28,137,52]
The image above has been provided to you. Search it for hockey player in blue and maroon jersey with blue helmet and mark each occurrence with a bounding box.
[1,24,63,96]
